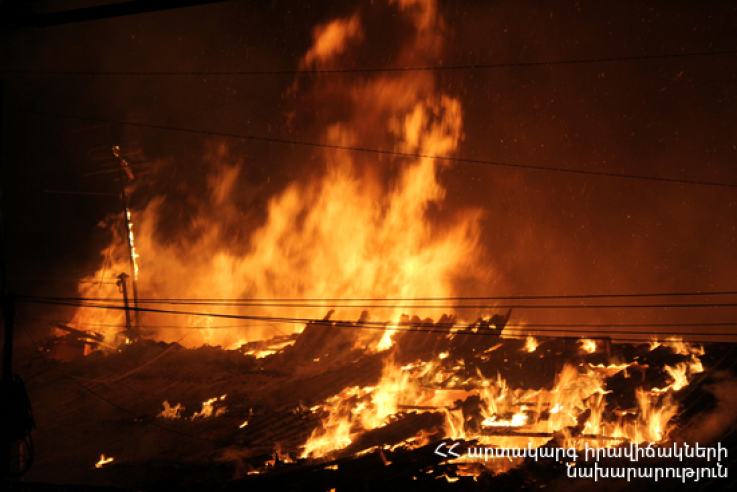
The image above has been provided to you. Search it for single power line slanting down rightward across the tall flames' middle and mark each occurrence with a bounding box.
[3,107,737,188]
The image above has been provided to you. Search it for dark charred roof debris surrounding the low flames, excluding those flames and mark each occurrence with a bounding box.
[12,316,737,491]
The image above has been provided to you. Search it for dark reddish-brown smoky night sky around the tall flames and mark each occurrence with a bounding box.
[0,0,737,340]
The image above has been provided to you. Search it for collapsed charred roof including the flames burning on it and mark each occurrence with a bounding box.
[12,312,735,490]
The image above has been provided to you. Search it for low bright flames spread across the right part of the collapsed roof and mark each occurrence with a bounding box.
[296,328,700,471]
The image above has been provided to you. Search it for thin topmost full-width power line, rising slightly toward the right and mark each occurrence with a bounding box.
[0,50,737,77]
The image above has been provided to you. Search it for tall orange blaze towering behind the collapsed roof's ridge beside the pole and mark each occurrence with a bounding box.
[67,1,488,351]
